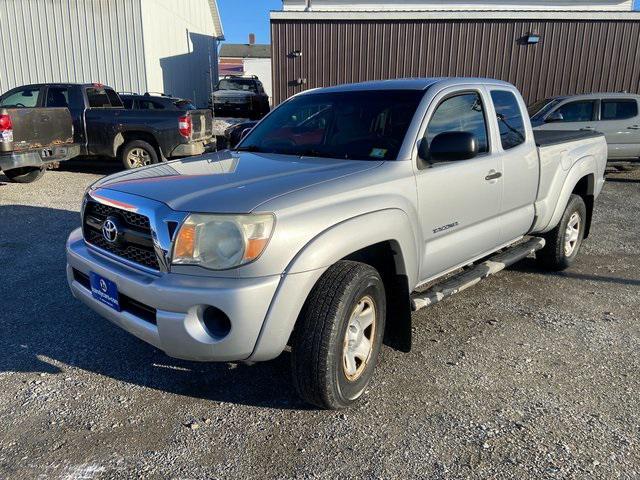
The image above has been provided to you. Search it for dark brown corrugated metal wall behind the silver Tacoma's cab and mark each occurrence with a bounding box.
[271,19,640,103]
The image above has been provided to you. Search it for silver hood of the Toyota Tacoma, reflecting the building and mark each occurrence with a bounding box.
[92,150,383,213]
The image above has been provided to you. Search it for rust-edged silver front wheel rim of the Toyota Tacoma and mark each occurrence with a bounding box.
[342,295,376,382]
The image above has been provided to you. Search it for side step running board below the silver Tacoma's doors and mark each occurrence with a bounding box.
[411,237,545,311]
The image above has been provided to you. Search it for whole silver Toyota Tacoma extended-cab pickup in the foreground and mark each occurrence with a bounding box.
[67,78,607,408]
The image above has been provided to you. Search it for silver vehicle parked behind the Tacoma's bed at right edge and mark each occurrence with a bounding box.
[529,93,640,160]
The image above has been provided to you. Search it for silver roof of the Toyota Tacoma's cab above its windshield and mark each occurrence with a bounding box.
[303,77,513,93]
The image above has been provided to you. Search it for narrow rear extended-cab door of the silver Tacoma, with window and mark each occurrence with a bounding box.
[487,86,540,243]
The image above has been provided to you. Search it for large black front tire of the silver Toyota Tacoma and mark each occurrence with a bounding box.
[291,261,386,409]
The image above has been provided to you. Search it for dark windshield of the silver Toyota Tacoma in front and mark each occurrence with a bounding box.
[237,90,424,160]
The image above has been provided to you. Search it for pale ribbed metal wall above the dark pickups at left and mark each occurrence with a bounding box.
[0,0,147,92]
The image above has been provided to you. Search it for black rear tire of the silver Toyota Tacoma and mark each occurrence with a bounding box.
[536,195,587,271]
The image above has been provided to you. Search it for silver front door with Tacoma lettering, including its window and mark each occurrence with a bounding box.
[416,85,502,281]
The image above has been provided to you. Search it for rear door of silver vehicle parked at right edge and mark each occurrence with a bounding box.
[596,97,640,159]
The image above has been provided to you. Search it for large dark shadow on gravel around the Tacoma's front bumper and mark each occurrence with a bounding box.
[0,205,308,409]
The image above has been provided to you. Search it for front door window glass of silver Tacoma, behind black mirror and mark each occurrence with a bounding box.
[425,93,489,153]
